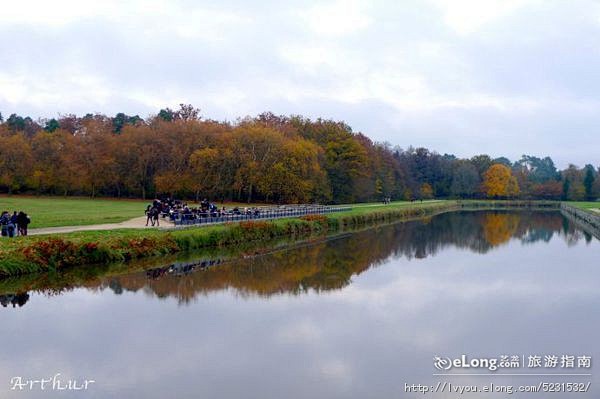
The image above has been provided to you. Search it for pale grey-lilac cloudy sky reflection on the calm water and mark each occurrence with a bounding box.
[0,211,600,398]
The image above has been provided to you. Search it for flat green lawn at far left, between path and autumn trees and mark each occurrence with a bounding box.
[0,196,150,229]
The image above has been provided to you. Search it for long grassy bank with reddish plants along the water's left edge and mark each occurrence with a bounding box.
[0,201,456,276]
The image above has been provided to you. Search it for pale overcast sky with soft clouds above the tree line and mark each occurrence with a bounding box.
[0,0,600,166]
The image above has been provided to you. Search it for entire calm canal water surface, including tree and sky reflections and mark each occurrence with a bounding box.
[0,211,600,399]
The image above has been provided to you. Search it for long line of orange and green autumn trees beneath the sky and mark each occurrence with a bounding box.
[0,104,600,203]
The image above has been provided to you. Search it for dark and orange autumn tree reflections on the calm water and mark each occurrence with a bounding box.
[0,211,587,304]
